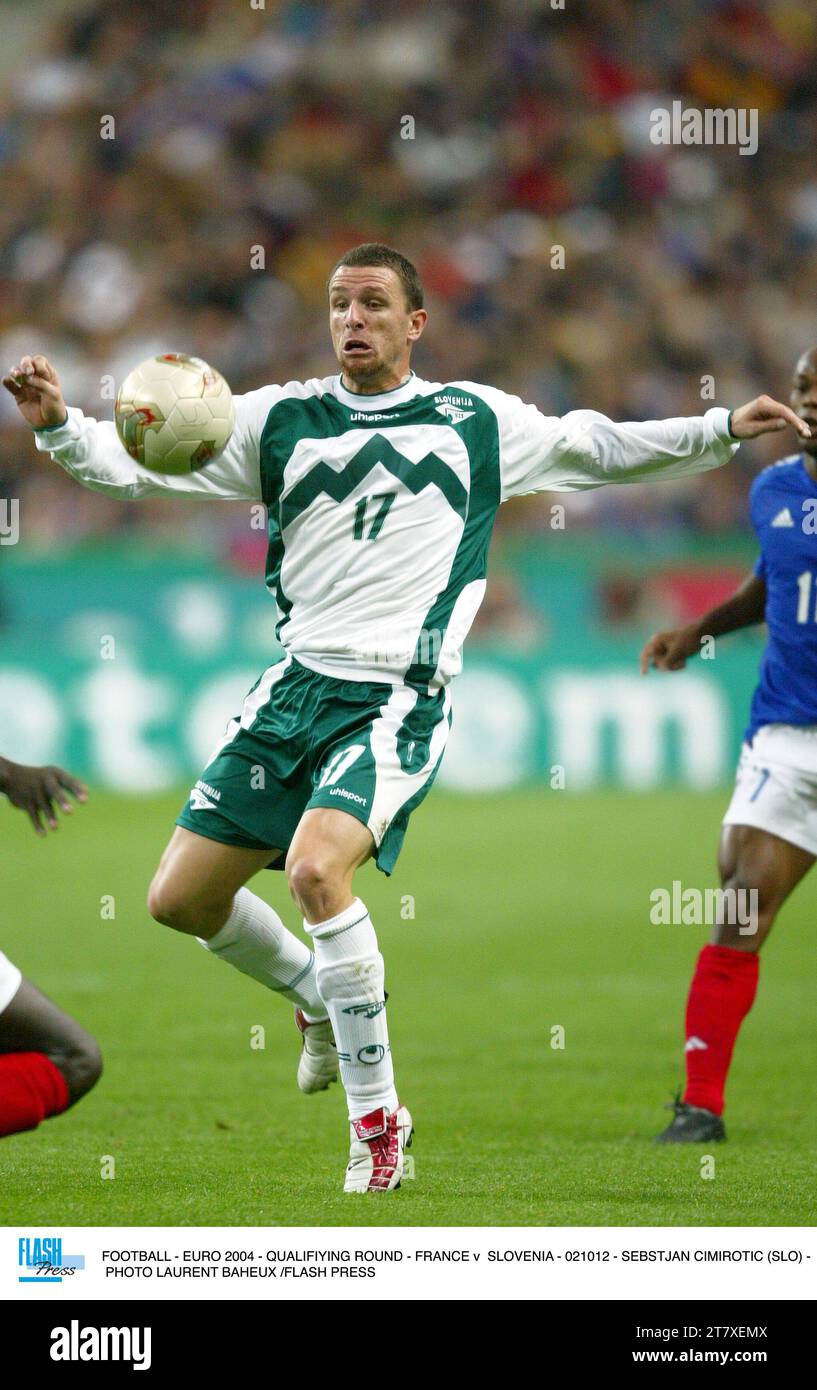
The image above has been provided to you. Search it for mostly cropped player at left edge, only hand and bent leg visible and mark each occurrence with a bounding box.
[0,758,101,1136]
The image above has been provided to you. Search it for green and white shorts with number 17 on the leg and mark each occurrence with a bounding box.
[176,656,452,873]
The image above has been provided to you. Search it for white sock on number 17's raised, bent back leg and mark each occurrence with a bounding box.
[197,888,327,1023]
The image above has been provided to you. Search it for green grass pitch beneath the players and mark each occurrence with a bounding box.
[0,791,817,1226]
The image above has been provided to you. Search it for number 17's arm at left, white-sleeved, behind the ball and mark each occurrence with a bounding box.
[3,353,262,502]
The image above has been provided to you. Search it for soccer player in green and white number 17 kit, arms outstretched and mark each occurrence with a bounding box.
[4,243,809,1193]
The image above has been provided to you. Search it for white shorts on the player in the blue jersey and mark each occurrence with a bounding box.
[724,724,817,855]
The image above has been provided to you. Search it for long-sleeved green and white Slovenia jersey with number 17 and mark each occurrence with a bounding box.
[36,373,738,691]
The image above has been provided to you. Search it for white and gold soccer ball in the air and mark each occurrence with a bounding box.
[114,352,235,473]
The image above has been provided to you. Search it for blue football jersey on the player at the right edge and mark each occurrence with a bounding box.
[746,455,817,741]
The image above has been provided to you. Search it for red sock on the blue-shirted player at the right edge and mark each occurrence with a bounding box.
[684,947,760,1115]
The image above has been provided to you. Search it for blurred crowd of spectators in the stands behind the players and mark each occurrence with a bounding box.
[0,0,817,563]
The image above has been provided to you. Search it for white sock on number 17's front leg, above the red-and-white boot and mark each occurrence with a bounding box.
[304,898,399,1120]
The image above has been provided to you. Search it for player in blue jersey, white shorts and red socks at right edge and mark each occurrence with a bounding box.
[641,348,817,1144]
